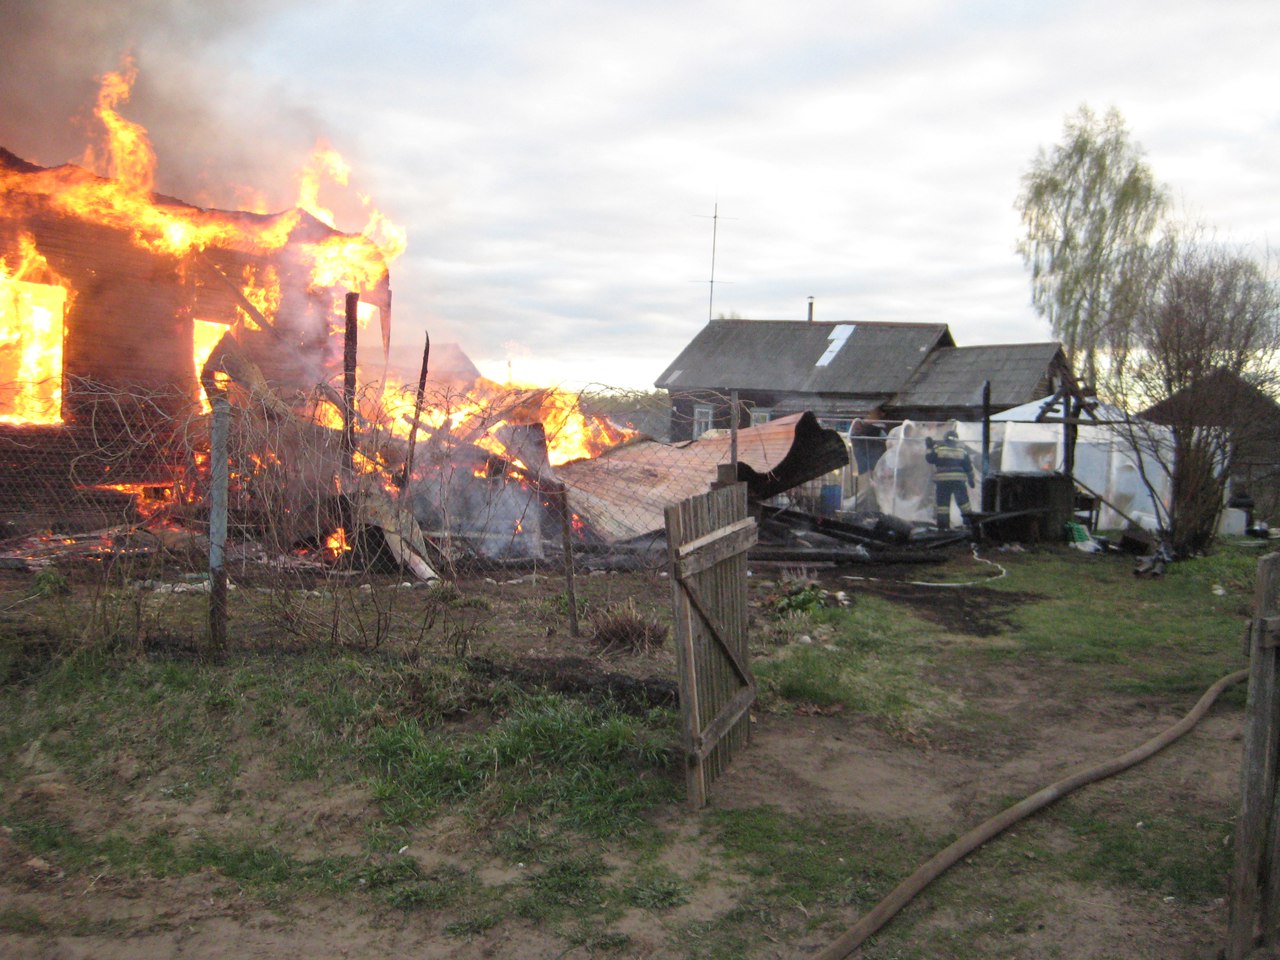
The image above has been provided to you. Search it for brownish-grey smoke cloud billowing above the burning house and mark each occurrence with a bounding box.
[0,0,324,209]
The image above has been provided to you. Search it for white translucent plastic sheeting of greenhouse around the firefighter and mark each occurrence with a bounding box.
[856,414,1170,530]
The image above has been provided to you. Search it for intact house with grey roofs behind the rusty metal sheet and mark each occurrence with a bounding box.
[654,320,1070,440]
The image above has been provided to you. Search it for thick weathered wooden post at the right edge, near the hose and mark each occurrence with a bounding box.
[1225,553,1280,960]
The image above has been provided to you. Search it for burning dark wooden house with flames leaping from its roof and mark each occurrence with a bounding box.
[0,60,409,568]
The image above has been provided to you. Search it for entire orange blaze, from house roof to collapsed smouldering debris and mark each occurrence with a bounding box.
[0,61,628,556]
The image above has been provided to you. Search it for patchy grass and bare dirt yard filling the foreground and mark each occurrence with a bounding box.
[0,544,1260,960]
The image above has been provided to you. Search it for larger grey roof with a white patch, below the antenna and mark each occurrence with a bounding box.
[654,320,955,396]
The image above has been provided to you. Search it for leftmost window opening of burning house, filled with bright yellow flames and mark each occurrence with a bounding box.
[0,275,67,424]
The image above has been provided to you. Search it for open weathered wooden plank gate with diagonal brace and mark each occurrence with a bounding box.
[666,483,755,809]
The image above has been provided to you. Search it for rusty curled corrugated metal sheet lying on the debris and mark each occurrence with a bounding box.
[556,412,849,543]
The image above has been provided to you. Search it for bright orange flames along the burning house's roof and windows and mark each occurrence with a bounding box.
[0,55,404,424]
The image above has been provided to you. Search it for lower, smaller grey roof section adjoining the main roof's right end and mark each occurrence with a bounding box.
[893,343,1068,407]
